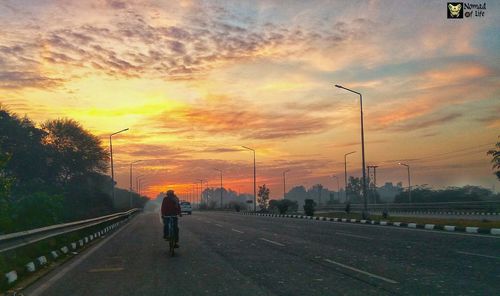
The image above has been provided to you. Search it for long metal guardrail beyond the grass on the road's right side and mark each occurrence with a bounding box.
[316,201,500,212]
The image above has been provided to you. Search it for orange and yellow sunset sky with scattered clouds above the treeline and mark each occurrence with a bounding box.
[0,0,500,198]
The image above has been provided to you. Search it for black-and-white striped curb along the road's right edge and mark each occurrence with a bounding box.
[240,212,500,235]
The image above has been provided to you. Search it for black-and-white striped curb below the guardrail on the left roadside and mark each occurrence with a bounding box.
[0,218,130,294]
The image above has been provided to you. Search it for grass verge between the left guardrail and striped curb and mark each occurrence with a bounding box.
[0,221,125,295]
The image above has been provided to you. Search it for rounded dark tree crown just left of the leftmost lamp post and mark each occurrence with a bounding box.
[42,119,109,185]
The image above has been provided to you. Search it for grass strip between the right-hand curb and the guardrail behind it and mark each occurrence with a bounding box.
[314,212,500,228]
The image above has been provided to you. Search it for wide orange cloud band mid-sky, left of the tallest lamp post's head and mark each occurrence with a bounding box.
[149,98,331,140]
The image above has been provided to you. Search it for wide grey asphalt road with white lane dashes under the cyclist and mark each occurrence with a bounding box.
[24,212,500,295]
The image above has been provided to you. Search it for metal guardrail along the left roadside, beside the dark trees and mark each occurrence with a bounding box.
[0,209,140,253]
